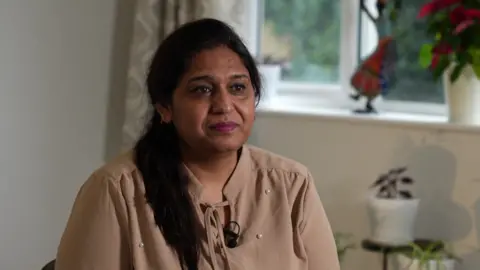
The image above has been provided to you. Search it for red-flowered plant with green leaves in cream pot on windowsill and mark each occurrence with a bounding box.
[418,0,480,124]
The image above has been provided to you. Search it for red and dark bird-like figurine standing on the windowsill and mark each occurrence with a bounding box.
[350,0,400,113]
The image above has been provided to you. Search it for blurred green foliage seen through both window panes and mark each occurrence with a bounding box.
[264,0,444,103]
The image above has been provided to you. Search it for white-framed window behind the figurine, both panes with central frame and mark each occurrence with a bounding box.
[259,0,444,113]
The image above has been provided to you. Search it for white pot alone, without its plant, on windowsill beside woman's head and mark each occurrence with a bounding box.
[258,64,282,107]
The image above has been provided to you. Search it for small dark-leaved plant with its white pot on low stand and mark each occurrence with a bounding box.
[368,167,420,245]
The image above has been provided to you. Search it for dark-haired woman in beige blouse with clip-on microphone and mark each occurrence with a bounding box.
[56,19,339,270]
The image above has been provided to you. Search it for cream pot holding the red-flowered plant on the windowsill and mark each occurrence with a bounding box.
[443,65,480,125]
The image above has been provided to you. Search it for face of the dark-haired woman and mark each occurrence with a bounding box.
[158,46,255,152]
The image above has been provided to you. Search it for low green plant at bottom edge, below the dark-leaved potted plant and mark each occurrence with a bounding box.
[397,241,460,270]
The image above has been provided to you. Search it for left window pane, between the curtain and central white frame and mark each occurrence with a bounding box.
[261,0,341,84]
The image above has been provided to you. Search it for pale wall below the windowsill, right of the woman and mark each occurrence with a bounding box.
[251,113,480,270]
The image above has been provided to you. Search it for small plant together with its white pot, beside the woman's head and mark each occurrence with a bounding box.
[258,55,285,106]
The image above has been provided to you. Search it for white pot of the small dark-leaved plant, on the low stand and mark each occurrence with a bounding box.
[369,197,420,245]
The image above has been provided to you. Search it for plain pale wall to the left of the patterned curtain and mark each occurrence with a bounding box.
[0,0,122,270]
